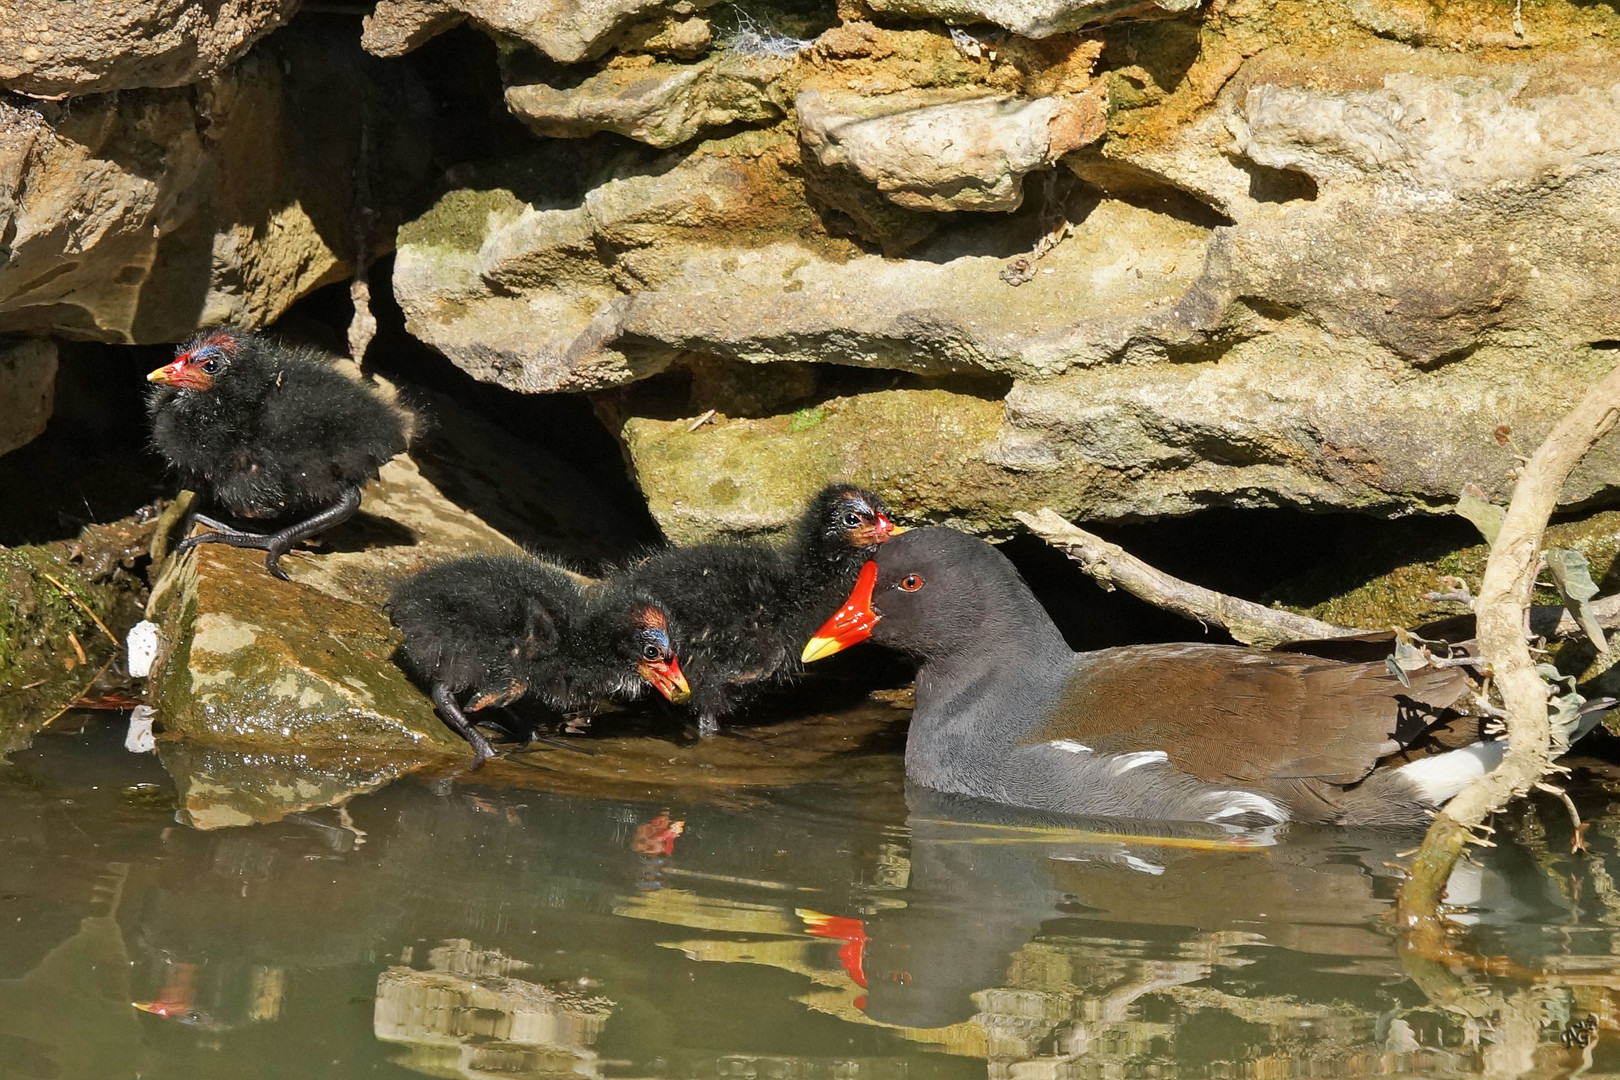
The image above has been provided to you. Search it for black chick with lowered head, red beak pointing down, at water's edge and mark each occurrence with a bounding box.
[387,555,689,769]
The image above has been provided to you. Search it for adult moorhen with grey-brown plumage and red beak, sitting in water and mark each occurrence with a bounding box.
[804,528,1502,827]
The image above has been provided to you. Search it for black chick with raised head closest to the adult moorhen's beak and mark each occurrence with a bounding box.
[620,484,897,735]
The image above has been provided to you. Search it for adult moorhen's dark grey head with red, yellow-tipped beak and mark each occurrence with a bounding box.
[804,526,1045,664]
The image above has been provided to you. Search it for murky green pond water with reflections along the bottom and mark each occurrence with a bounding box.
[9,714,1620,1080]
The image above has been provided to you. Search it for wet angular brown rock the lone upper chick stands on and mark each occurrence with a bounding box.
[147,458,512,761]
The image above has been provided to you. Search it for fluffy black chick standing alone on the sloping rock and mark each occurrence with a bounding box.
[147,327,411,581]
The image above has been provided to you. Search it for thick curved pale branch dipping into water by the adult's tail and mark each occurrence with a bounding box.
[1396,359,1620,932]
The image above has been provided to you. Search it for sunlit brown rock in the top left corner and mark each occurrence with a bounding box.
[0,0,301,97]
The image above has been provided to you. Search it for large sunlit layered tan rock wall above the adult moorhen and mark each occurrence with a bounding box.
[395,2,1620,541]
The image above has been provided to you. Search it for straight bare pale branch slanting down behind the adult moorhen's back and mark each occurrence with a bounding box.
[1013,508,1371,646]
